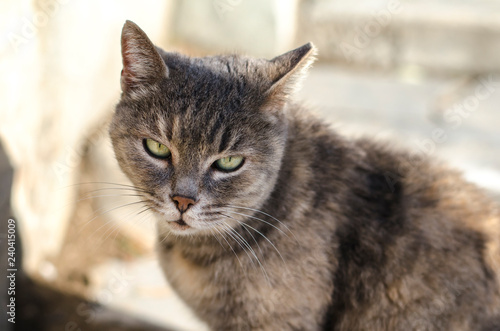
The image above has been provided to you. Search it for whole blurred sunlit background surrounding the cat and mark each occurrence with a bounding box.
[0,0,500,330]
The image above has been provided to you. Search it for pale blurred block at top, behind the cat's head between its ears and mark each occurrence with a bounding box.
[172,0,299,58]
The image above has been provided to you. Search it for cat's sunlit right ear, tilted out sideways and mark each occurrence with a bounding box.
[267,43,316,105]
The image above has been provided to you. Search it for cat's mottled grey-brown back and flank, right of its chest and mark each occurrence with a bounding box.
[292,108,500,330]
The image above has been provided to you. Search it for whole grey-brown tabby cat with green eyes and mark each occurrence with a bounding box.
[110,21,500,330]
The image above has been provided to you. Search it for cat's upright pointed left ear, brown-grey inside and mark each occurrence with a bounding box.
[121,21,168,92]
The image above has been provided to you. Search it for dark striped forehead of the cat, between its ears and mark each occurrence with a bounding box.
[150,56,265,136]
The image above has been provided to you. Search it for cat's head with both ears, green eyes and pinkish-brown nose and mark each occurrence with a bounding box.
[110,21,314,235]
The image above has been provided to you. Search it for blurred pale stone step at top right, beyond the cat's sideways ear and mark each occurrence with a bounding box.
[297,0,500,73]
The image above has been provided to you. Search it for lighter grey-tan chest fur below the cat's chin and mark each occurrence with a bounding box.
[158,233,333,330]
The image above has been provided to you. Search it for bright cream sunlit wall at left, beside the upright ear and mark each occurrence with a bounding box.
[0,0,172,271]
